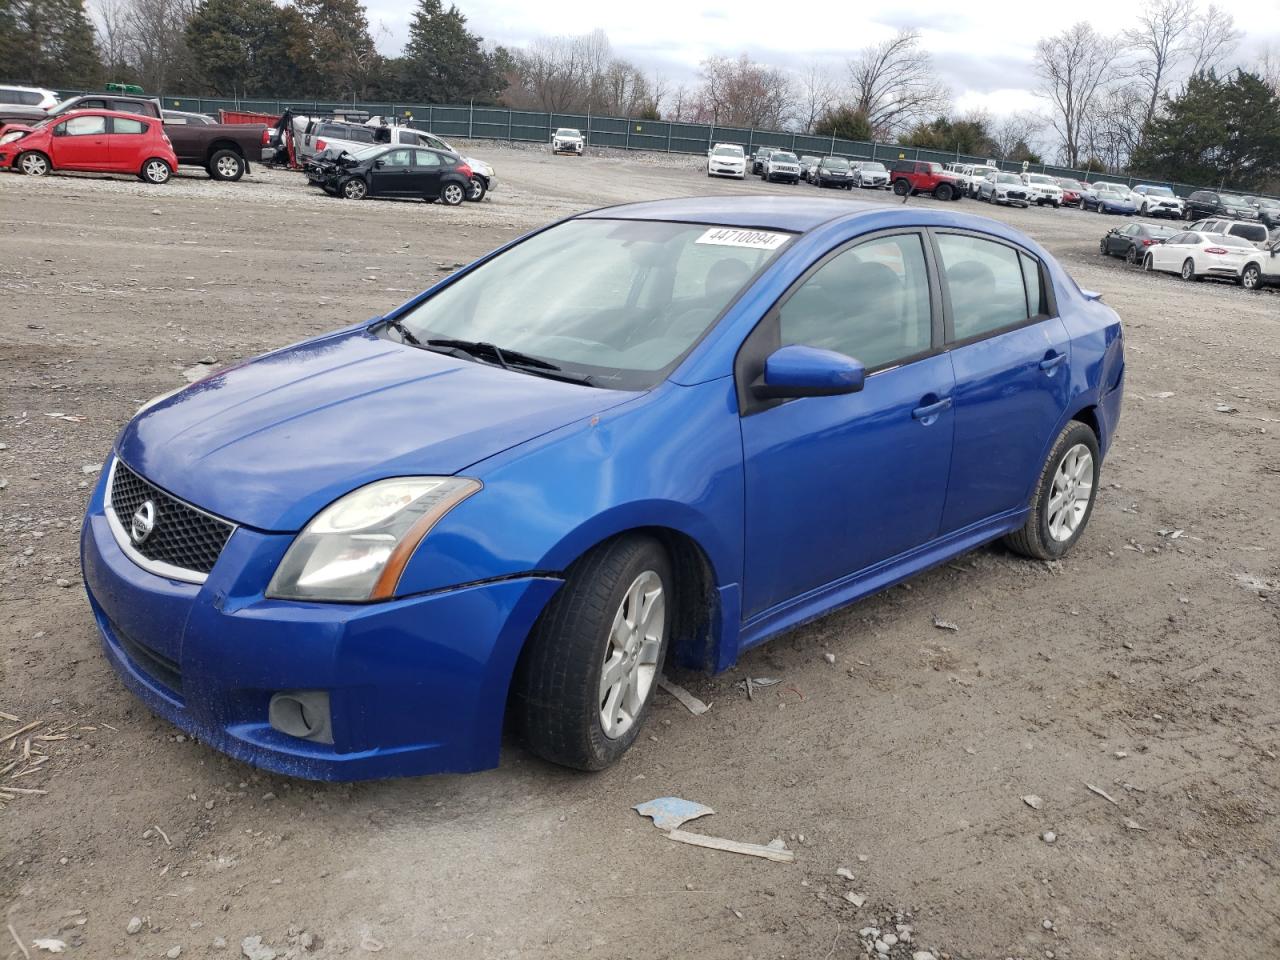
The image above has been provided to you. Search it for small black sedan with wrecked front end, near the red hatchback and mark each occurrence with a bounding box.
[307,145,471,206]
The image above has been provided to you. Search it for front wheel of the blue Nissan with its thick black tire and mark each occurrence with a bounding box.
[511,535,673,771]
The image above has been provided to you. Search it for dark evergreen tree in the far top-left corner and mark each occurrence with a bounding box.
[0,0,102,88]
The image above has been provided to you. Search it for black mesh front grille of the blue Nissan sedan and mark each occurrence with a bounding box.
[111,460,236,573]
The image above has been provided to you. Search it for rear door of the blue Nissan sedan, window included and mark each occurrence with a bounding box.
[932,229,1071,535]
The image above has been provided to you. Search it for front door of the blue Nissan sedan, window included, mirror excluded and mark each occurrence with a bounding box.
[742,230,954,618]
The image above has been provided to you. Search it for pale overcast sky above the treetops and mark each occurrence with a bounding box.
[366,0,1280,114]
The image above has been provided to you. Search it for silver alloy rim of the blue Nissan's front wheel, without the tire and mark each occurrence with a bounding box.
[599,570,667,740]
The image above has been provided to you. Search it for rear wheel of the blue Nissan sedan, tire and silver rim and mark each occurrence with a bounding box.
[1005,420,1102,561]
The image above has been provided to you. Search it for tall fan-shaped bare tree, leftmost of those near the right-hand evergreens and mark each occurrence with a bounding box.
[1036,20,1121,166]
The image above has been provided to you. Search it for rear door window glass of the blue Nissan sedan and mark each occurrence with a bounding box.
[938,233,1043,340]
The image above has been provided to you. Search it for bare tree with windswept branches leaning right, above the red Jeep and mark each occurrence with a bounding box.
[849,29,950,138]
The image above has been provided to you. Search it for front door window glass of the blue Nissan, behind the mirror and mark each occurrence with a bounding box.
[778,233,933,370]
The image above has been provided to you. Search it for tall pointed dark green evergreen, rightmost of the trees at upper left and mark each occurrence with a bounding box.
[401,0,496,104]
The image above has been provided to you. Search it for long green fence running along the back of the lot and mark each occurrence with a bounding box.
[58,91,1269,197]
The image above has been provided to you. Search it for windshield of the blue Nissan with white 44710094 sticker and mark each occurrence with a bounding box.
[399,219,791,389]
